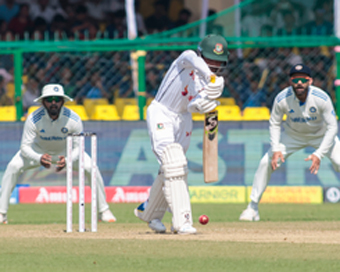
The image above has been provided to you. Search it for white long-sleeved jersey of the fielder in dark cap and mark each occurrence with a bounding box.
[269,86,338,159]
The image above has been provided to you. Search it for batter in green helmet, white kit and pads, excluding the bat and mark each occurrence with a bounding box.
[135,35,229,234]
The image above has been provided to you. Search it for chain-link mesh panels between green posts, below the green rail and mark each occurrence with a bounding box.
[0,47,336,118]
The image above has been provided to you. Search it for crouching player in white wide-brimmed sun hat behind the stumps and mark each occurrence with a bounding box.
[0,84,116,224]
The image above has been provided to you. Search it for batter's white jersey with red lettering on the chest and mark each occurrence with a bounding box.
[155,50,212,113]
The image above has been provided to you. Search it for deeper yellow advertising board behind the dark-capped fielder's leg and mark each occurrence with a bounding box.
[247,186,323,204]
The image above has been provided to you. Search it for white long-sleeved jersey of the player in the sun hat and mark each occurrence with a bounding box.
[20,107,83,162]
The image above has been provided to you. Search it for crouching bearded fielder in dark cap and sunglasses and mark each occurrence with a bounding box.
[240,64,340,221]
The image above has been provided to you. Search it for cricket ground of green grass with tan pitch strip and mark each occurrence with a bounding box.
[0,204,340,272]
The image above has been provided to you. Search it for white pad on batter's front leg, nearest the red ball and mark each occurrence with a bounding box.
[162,143,192,231]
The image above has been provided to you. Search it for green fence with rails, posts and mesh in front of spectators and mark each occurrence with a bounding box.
[0,0,340,120]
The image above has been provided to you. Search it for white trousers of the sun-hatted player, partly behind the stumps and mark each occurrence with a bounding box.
[0,150,109,214]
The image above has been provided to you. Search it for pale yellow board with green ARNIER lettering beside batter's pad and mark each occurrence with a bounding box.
[189,186,246,203]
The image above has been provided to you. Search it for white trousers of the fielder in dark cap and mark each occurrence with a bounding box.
[250,132,340,203]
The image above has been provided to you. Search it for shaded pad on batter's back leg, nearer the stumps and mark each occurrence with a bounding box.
[138,174,168,222]
